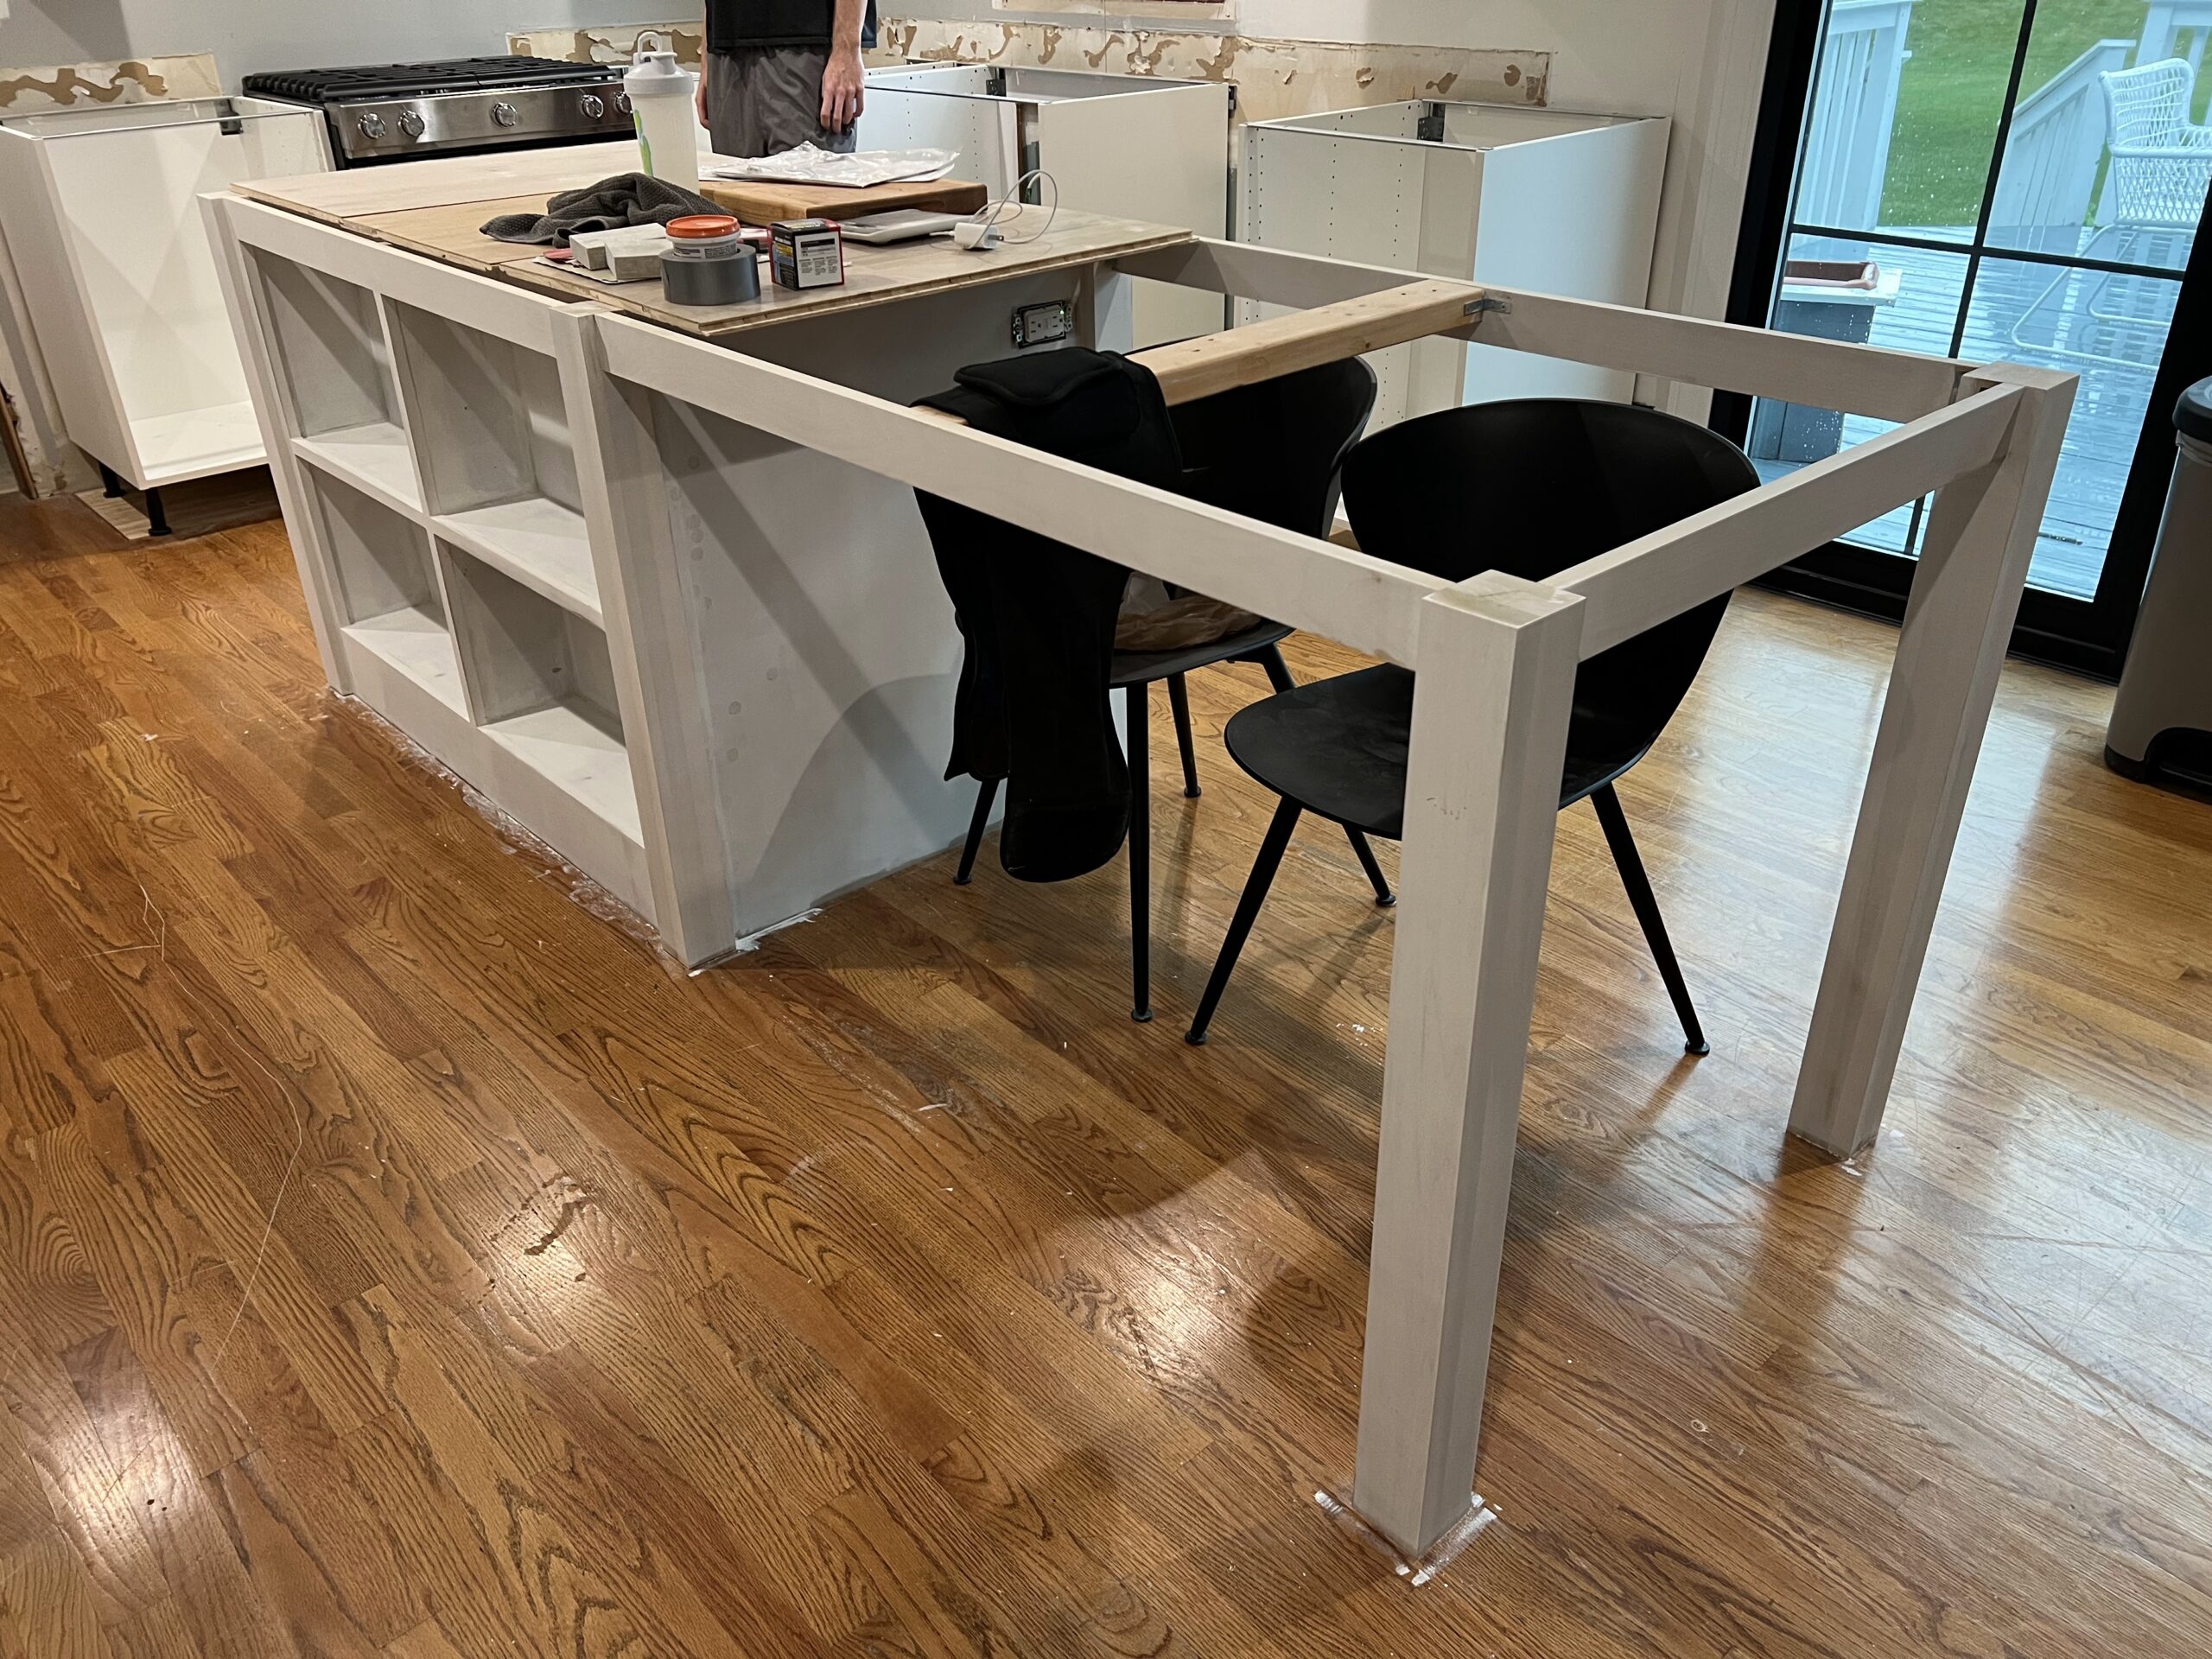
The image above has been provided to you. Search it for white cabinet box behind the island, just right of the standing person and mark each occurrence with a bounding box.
[861,64,1230,347]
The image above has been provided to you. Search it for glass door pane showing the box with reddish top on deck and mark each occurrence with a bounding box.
[1745,237,1967,553]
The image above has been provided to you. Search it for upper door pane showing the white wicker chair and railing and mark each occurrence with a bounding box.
[1988,0,2212,270]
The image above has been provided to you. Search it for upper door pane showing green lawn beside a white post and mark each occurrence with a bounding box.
[1796,0,2025,241]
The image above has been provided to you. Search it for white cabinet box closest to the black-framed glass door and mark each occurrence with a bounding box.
[1236,99,1668,427]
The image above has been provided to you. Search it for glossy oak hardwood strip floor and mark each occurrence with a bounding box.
[0,486,2212,1659]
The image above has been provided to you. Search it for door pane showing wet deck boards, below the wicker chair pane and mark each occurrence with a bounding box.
[1960,259,2181,600]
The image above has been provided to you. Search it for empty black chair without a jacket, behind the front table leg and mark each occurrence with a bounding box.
[1188,398,1758,1055]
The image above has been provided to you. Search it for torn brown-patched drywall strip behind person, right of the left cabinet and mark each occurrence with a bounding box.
[506,20,1551,122]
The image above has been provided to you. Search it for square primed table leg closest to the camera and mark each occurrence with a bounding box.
[1351,573,1581,1555]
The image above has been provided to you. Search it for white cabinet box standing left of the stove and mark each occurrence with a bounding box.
[0,98,329,529]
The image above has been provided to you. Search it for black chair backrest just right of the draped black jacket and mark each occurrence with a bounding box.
[1168,356,1376,536]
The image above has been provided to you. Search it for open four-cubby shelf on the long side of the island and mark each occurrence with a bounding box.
[213,207,652,920]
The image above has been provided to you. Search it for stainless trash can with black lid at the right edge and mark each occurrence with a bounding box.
[2104,380,2212,791]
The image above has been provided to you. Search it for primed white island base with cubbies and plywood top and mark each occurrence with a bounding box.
[208,146,1190,964]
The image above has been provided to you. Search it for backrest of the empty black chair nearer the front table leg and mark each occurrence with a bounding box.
[1344,398,1758,766]
